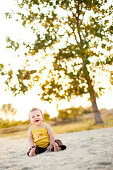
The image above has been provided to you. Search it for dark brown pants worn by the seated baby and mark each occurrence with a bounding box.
[27,139,66,156]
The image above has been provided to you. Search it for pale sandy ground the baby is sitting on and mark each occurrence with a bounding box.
[0,128,113,170]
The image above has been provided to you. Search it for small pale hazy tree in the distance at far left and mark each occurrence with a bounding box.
[0,103,17,119]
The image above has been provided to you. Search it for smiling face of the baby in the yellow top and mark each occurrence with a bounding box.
[29,110,43,125]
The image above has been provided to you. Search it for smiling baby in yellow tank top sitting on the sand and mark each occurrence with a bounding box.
[27,108,66,156]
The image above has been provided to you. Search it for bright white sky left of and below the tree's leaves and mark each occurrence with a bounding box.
[0,0,113,121]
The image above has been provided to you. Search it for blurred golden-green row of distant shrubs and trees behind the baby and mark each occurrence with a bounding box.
[0,103,92,128]
